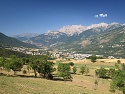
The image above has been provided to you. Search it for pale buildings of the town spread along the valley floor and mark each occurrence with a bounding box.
[7,47,114,60]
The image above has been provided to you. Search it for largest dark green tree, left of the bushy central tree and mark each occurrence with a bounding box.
[30,56,54,79]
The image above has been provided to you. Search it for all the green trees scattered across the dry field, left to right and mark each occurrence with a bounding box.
[0,55,125,94]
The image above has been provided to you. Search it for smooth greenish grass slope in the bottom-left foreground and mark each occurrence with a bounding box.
[0,76,84,94]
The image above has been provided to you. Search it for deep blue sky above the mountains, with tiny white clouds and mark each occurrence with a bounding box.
[0,0,125,36]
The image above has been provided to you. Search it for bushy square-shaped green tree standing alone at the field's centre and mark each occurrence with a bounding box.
[58,63,72,81]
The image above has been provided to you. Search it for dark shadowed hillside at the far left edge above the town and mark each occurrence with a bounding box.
[0,33,36,47]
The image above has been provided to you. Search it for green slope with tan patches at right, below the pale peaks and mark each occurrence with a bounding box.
[55,26,125,58]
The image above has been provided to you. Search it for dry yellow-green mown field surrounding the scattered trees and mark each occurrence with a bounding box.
[0,59,125,94]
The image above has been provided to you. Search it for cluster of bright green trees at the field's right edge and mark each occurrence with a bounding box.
[95,60,125,94]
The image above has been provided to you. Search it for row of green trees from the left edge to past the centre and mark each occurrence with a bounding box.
[0,55,89,81]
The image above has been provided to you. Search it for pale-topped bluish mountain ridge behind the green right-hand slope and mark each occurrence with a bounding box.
[27,23,123,47]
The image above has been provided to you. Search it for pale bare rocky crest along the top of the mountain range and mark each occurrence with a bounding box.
[44,22,125,36]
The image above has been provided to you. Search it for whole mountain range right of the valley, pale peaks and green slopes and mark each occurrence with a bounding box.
[3,22,125,57]
